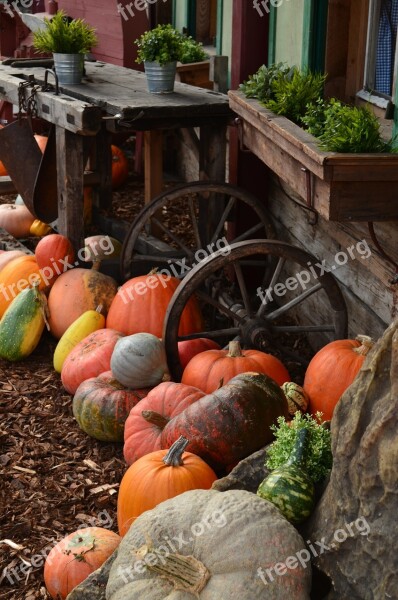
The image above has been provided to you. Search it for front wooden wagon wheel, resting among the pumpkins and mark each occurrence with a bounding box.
[163,240,347,381]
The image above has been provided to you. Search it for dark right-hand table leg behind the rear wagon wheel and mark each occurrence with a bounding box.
[198,124,227,245]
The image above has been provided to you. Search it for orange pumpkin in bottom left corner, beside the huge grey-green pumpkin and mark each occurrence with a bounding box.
[44,527,120,600]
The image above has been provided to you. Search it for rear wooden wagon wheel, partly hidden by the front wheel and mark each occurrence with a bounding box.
[121,181,276,279]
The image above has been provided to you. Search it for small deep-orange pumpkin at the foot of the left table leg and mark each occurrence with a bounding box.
[35,233,75,286]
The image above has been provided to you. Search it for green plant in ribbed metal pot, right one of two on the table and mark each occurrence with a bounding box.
[135,24,183,94]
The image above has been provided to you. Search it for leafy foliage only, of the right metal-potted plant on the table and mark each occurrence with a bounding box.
[134,24,183,65]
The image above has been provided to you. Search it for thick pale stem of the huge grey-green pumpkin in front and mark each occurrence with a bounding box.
[136,545,210,598]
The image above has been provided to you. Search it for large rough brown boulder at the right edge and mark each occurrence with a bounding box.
[305,320,398,600]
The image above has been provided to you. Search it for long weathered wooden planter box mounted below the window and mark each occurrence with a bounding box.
[229,91,398,221]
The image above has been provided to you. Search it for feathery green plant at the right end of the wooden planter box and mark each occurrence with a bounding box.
[302,98,398,153]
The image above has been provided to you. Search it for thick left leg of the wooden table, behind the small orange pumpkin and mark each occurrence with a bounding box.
[56,127,84,253]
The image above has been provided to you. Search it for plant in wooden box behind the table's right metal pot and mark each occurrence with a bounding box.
[177,35,213,89]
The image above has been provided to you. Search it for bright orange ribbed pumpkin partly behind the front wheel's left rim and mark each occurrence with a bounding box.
[106,273,202,338]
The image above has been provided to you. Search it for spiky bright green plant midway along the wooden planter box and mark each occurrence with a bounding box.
[266,67,326,124]
